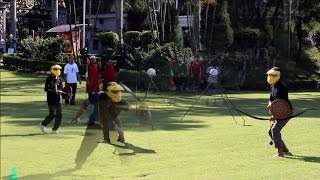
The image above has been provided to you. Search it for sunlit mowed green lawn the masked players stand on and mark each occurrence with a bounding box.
[0,69,320,180]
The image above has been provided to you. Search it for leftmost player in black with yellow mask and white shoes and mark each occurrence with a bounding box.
[39,64,63,134]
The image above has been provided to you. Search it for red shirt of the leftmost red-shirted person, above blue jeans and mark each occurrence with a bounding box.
[87,63,100,93]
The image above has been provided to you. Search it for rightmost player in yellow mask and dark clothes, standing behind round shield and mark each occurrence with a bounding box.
[266,67,292,157]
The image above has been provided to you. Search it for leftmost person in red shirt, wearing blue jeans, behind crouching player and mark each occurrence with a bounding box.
[73,56,100,126]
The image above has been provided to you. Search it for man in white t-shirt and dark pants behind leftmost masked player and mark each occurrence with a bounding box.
[64,56,81,105]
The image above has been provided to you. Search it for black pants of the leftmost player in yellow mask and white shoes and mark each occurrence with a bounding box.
[42,104,62,131]
